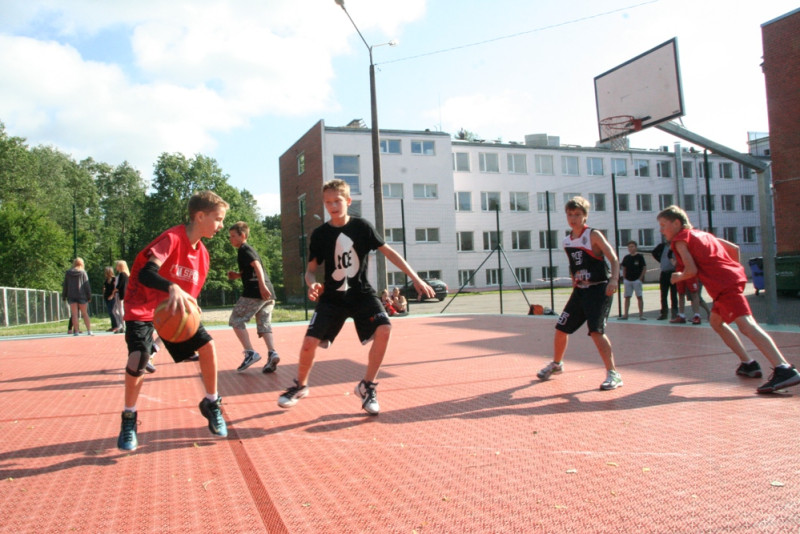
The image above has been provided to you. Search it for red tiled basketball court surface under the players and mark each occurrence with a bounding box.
[0,315,800,533]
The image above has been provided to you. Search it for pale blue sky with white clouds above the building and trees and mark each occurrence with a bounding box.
[0,0,797,215]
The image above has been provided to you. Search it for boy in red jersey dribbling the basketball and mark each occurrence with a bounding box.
[117,191,228,451]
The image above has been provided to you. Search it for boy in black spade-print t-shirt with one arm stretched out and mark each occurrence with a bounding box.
[278,179,434,415]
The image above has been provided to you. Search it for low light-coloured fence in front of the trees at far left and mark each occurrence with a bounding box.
[0,287,106,326]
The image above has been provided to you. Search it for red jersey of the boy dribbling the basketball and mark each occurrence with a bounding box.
[125,225,209,321]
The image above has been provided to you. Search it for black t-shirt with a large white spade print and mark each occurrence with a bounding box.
[309,217,384,302]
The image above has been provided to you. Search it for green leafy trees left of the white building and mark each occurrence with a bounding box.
[0,122,283,304]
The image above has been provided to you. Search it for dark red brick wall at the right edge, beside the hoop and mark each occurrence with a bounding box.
[761,10,800,255]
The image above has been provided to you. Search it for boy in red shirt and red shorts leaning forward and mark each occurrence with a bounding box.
[658,206,800,393]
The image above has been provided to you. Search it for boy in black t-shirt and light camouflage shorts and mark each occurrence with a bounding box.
[228,221,281,373]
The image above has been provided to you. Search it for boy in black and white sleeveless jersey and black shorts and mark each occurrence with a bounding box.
[536,197,622,390]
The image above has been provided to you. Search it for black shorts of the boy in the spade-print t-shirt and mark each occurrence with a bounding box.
[306,294,391,348]
